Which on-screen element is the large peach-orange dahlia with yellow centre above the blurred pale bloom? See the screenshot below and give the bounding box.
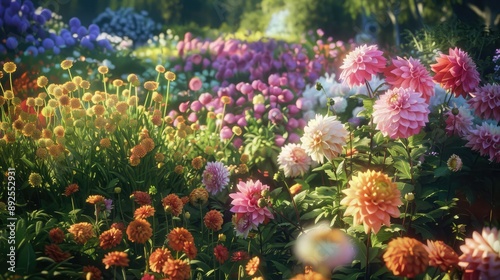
[340,170,403,234]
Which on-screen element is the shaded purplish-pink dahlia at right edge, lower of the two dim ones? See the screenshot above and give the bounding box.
[465,122,500,162]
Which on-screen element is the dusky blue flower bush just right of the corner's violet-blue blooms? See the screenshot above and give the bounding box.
[93,8,161,46]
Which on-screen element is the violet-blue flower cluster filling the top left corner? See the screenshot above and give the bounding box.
[0,0,113,56]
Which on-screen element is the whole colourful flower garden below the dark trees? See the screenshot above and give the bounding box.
[0,0,500,279]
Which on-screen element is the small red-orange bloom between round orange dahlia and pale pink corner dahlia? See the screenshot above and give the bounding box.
[426,240,458,272]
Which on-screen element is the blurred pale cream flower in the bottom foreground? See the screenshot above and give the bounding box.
[294,223,355,271]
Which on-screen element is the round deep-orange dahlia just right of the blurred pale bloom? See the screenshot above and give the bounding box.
[383,237,429,278]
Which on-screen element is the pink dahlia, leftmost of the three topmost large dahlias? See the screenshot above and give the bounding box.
[340,45,387,88]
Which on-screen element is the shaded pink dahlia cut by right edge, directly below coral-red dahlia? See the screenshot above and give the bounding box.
[467,84,500,122]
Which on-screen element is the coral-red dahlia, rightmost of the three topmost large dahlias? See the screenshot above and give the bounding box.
[431,48,480,97]
